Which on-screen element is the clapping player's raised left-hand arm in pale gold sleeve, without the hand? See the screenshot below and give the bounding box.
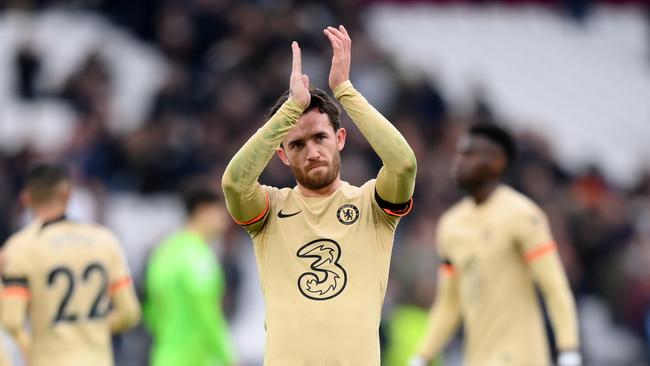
[221,100,302,222]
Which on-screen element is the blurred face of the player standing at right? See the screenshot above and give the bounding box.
[451,135,500,190]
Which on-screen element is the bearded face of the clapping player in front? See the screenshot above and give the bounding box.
[278,109,345,190]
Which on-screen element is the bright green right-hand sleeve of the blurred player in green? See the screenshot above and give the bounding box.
[183,254,234,365]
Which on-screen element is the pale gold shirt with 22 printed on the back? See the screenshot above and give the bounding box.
[3,220,130,366]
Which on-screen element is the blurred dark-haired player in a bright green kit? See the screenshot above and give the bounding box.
[144,183,234,366]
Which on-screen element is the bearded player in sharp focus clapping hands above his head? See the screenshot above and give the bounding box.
[222,26,416,366]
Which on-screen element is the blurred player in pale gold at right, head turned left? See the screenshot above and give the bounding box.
[411,124,581,366]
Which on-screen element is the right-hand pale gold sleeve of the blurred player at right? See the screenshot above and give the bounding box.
[515,206,579,351]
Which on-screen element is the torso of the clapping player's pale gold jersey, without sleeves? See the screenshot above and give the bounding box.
[244,180,399,366]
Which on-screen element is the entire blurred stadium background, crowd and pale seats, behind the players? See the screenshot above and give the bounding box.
[0,0,650,366]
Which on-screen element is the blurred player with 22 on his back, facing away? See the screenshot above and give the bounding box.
[1,163,140,366]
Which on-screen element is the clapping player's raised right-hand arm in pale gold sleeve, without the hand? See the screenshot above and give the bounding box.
[334,81,417,203]
